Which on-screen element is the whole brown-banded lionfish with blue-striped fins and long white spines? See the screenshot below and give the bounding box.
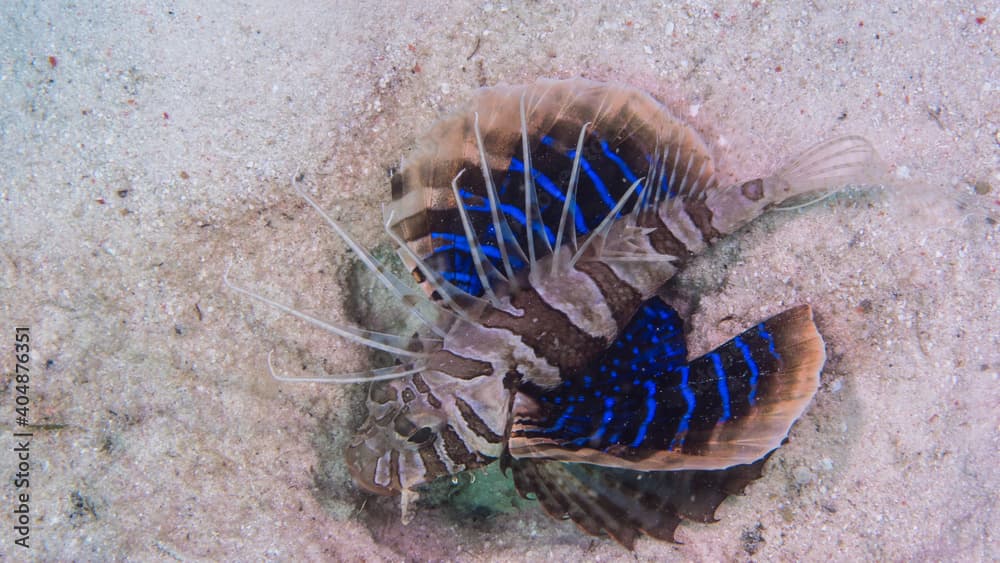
[227,79,877,549]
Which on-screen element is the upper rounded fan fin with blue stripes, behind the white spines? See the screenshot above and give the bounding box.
[387,80,716,302]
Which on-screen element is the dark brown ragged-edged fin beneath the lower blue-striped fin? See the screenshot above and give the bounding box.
[511,454,770,549]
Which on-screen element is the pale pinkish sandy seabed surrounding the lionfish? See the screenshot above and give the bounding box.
[0,1,1000,561]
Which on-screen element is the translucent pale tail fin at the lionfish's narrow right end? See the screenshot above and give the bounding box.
[705,135,884,234]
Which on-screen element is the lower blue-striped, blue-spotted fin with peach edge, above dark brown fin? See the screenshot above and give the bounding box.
[508,299,825,471]
